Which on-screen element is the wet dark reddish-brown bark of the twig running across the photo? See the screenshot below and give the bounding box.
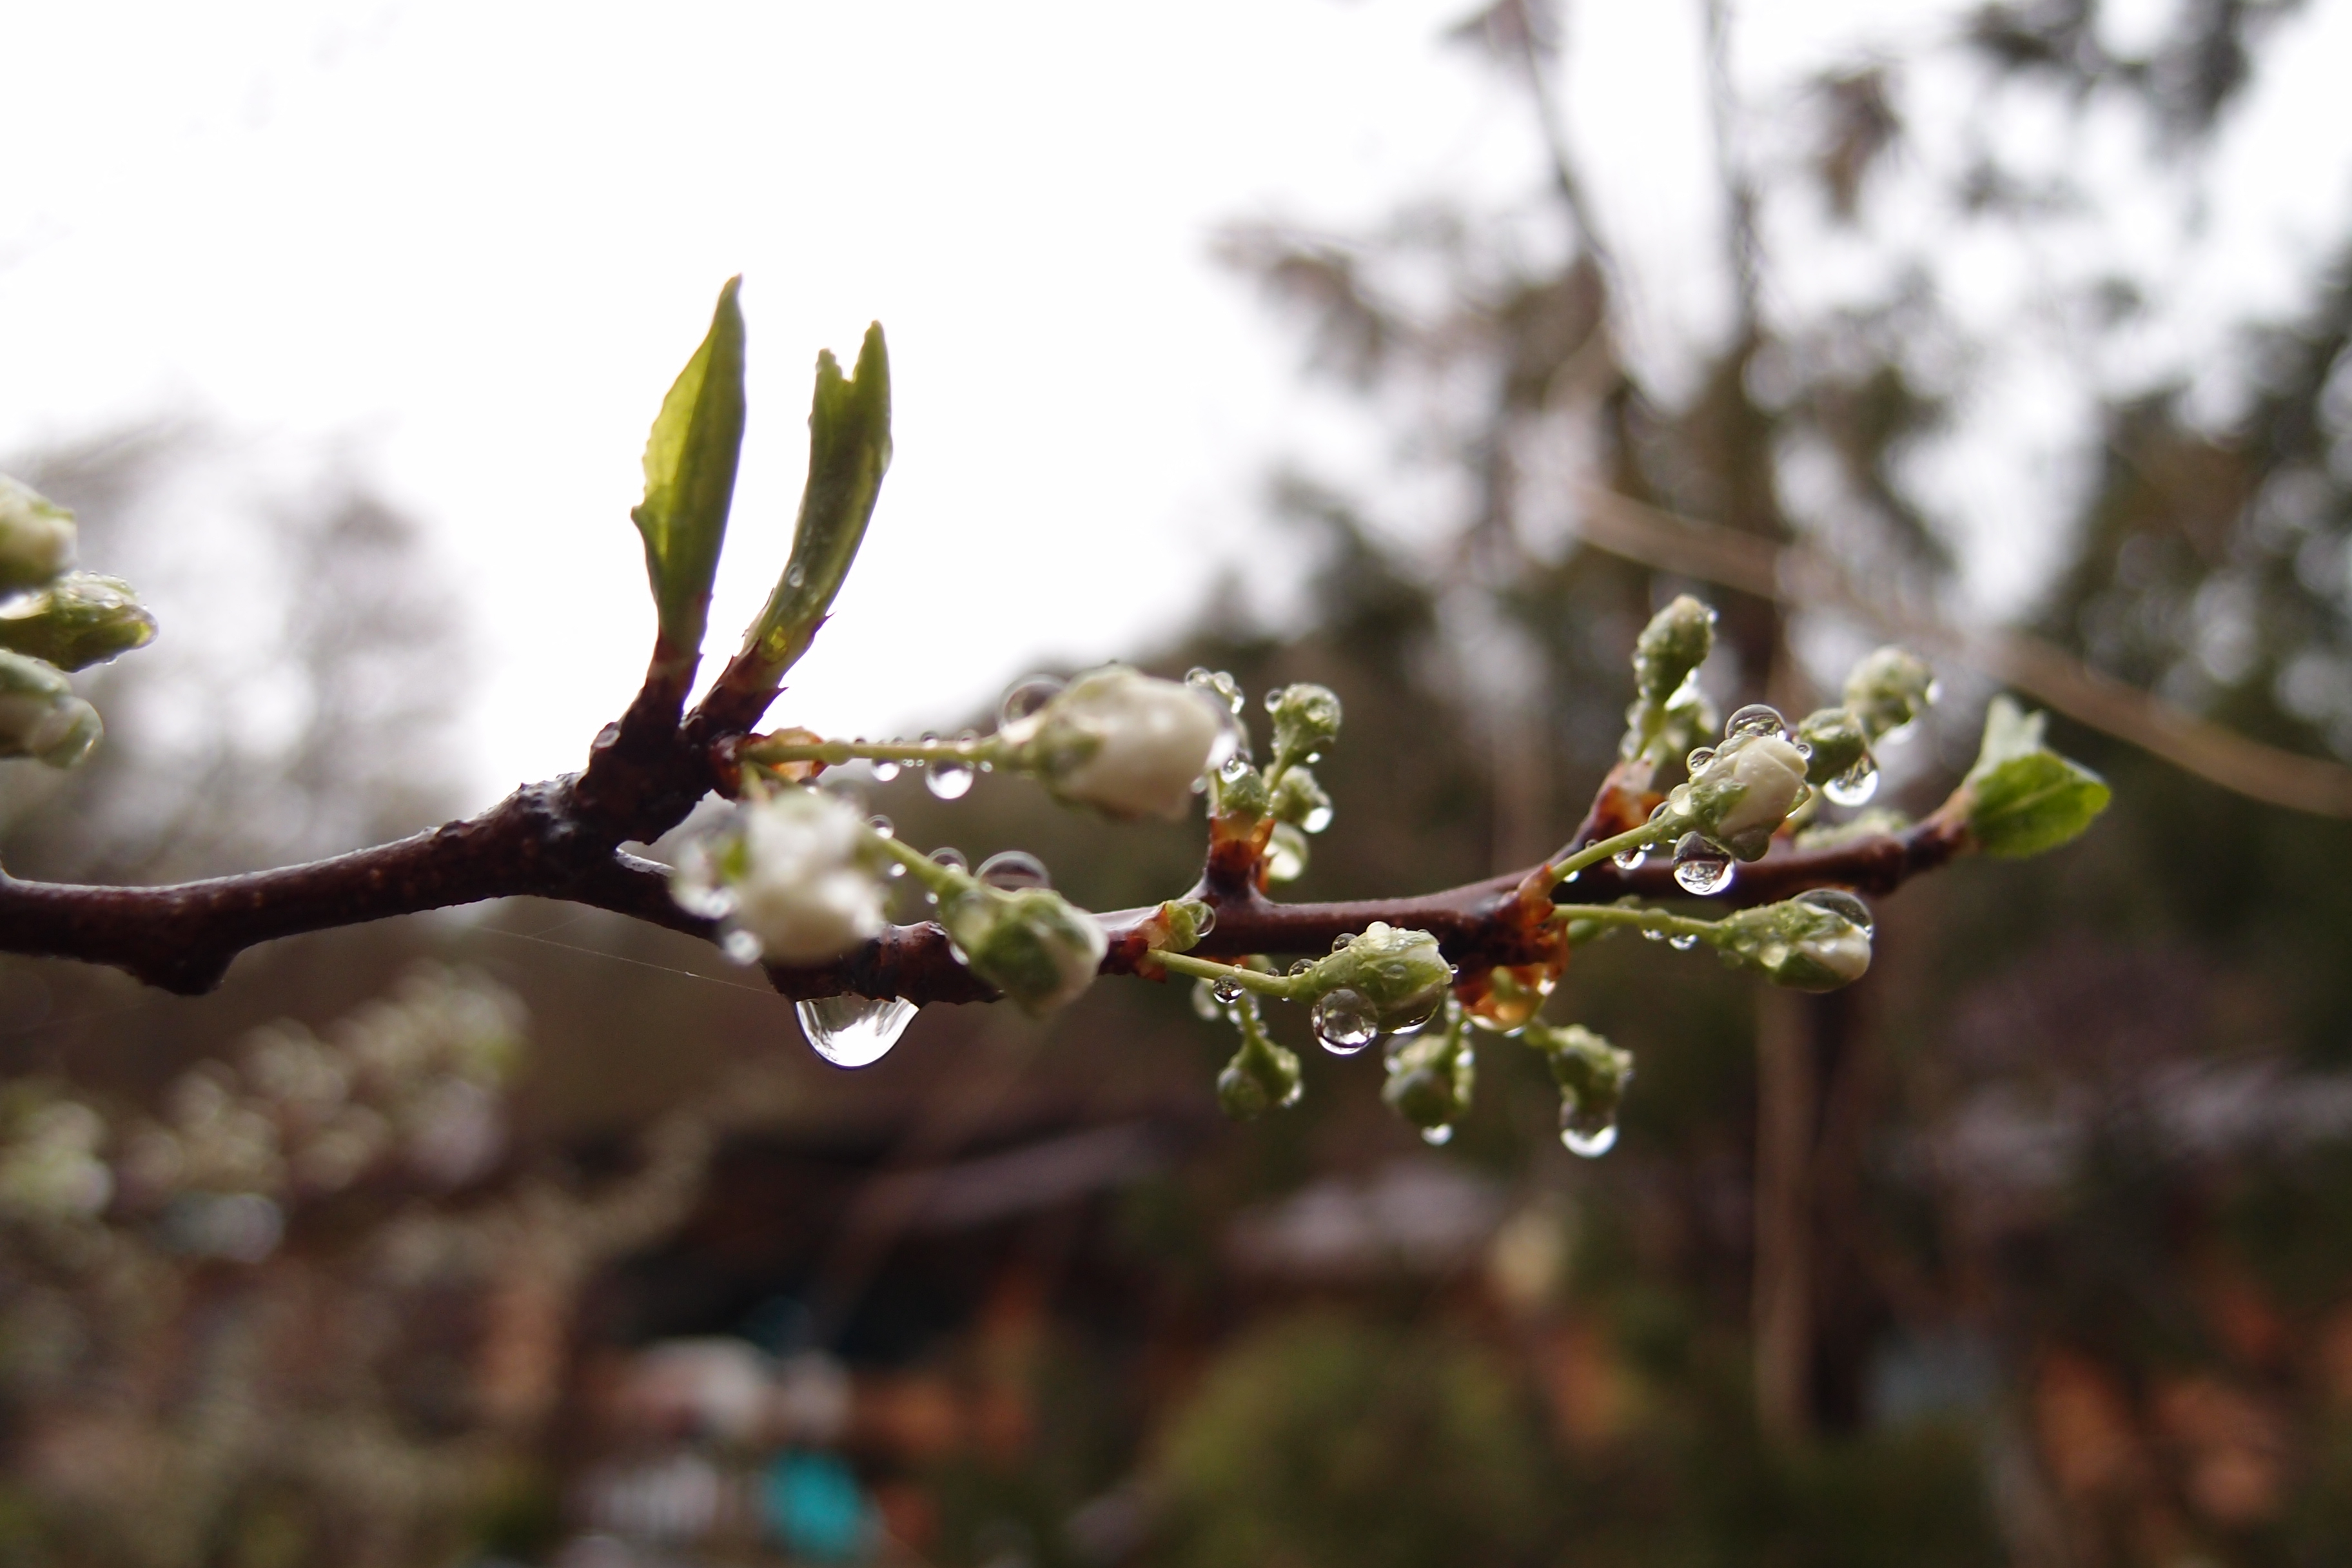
[0,625,1968,1004]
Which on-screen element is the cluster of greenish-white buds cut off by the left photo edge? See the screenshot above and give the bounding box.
[0,475,155,769]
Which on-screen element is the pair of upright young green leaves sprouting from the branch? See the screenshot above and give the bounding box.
[631,277,889,689]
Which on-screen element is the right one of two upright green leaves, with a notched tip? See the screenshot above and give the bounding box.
[743,322,889,684]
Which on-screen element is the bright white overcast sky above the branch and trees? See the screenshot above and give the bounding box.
[0,0,2345,792]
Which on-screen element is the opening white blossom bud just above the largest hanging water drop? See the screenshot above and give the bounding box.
[671,790,887,964]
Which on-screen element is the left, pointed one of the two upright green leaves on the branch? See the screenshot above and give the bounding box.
[631,277,743,663]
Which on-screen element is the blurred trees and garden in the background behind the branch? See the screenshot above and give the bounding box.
[0,0,2352,1568]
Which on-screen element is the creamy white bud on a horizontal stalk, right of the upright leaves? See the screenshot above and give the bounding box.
[1004,665,1233,821]
